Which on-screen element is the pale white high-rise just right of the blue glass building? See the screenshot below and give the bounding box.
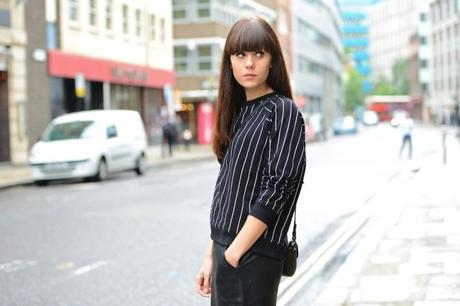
[369,0,431,119]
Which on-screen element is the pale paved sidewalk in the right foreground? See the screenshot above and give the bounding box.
[311,135,460,306]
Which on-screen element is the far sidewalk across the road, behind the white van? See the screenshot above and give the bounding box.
[0,145,215,189]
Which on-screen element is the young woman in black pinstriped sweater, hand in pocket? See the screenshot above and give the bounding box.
[196,17,306,306]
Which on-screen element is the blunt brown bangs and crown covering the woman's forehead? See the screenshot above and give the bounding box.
[225,18,275,56]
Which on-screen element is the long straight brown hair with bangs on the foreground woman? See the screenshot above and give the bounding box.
[212,17,292,160]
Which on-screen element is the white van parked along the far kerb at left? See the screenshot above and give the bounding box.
[29,110,147,185]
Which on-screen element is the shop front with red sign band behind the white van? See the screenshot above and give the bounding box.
[48,50,175,144]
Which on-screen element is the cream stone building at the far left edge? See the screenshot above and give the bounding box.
[0,0,30,164]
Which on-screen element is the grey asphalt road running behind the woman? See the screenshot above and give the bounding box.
[0,124,452,306]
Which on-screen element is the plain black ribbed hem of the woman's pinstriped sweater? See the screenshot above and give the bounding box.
[211,227,287,259]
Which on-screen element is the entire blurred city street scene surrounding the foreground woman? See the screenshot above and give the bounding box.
[0,0,460,306]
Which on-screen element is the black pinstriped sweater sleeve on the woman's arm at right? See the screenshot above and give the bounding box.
[249,99,306,225]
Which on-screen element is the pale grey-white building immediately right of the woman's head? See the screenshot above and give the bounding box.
[291,0,344,128]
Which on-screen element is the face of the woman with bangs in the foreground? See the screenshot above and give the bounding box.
[230,50,272,92]
